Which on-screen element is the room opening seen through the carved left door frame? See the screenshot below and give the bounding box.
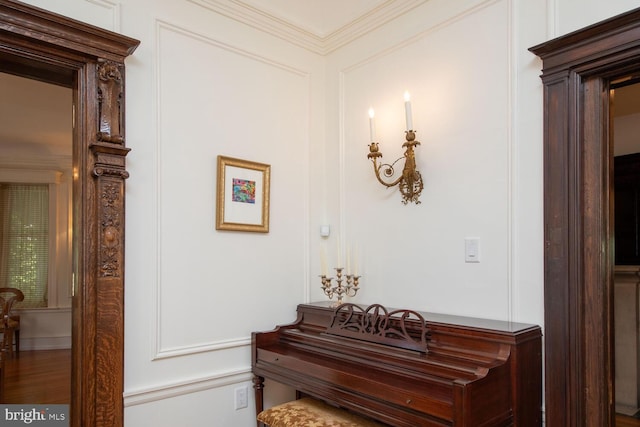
[0,73,73,404]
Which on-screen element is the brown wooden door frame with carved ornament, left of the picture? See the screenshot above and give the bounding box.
[0,0,139,427]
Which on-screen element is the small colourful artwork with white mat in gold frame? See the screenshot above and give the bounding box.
[216,156,271,233]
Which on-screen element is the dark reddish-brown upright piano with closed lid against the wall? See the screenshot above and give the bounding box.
[252,301,542,427]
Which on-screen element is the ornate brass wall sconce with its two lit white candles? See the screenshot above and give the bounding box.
[367,92,424,205]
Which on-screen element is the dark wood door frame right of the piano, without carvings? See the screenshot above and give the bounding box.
[530,9,640,427]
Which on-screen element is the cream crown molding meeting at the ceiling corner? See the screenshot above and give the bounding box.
[189,0,428,55]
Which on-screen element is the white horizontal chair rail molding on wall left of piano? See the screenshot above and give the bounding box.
[124,369,253,407]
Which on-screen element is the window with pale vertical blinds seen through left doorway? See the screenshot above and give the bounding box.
[0,183,49,308]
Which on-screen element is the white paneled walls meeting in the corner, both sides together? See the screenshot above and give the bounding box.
[17,0,636,427]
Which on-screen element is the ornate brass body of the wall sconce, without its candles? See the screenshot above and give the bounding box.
[367,130,424,205]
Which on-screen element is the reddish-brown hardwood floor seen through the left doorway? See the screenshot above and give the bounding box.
[2,349,71,404]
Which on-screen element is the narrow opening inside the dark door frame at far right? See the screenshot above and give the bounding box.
[609,80,640,427]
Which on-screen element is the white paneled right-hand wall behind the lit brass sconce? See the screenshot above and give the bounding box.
[328,0,545,323]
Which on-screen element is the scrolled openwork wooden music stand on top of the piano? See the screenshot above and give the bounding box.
[327,303,430,353]
